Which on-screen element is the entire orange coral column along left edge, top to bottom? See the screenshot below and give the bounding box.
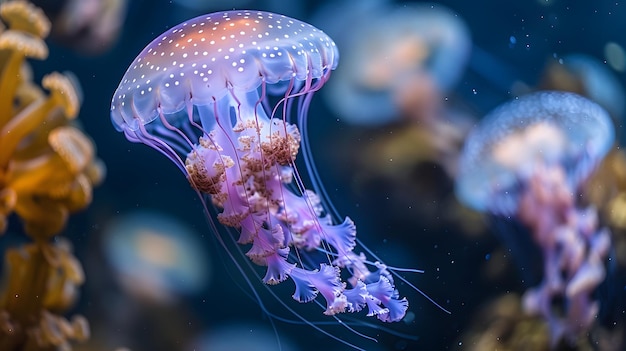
[0,0,105,351]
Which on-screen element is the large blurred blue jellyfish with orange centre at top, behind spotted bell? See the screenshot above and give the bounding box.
[319,1,471,126]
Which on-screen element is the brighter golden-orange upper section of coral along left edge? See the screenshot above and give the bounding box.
[0,1,103,238]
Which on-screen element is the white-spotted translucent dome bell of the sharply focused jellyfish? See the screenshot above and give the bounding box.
[111,10,339,131]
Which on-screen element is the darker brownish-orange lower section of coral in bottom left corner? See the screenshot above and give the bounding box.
[0,241,89,351]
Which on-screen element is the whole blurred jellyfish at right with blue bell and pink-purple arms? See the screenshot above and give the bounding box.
[456,91,615,346]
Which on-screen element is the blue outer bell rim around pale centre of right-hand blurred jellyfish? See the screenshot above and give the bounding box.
[455,91,615,215]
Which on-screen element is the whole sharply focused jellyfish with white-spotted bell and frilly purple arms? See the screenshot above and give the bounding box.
[111,11,428,346]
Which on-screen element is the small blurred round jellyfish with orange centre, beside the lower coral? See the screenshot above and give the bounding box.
[103,211,211,304]
